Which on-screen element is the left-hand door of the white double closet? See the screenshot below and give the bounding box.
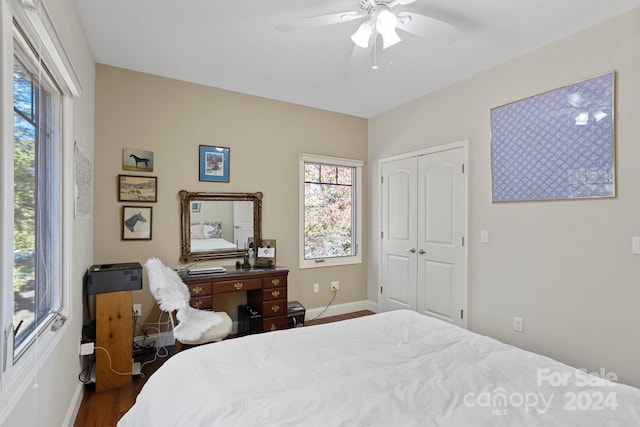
[379,157,418,311]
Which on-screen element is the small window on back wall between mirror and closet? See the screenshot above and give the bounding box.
[300,154,362,268]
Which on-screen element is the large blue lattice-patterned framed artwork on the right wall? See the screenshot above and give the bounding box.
[491,72,615,202]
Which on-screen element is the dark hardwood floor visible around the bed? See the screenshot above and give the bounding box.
[74,310,374,427]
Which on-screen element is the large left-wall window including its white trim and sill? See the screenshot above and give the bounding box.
[0,0,82,402]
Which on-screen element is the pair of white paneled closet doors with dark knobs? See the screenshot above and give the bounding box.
[378,147,467,327]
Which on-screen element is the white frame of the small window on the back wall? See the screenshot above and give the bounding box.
[298,153,364,269]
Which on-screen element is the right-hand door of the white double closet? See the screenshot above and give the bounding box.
[417,148,466,326]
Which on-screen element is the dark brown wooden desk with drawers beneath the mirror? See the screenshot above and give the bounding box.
[180,267,289,331]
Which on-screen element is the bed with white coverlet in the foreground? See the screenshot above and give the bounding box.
[118,310,640,427]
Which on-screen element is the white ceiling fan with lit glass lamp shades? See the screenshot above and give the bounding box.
[276,0,459,49]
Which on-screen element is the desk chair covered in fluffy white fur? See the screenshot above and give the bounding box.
[144,258,232,353]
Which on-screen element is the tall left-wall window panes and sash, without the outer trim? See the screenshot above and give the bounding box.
[13,31,62,354]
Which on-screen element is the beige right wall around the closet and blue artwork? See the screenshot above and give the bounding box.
[368,9,640,386]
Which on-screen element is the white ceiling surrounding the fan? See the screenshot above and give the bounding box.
[76,0,640,118]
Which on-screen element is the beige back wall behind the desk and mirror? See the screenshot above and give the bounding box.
[94,65,367,321]
